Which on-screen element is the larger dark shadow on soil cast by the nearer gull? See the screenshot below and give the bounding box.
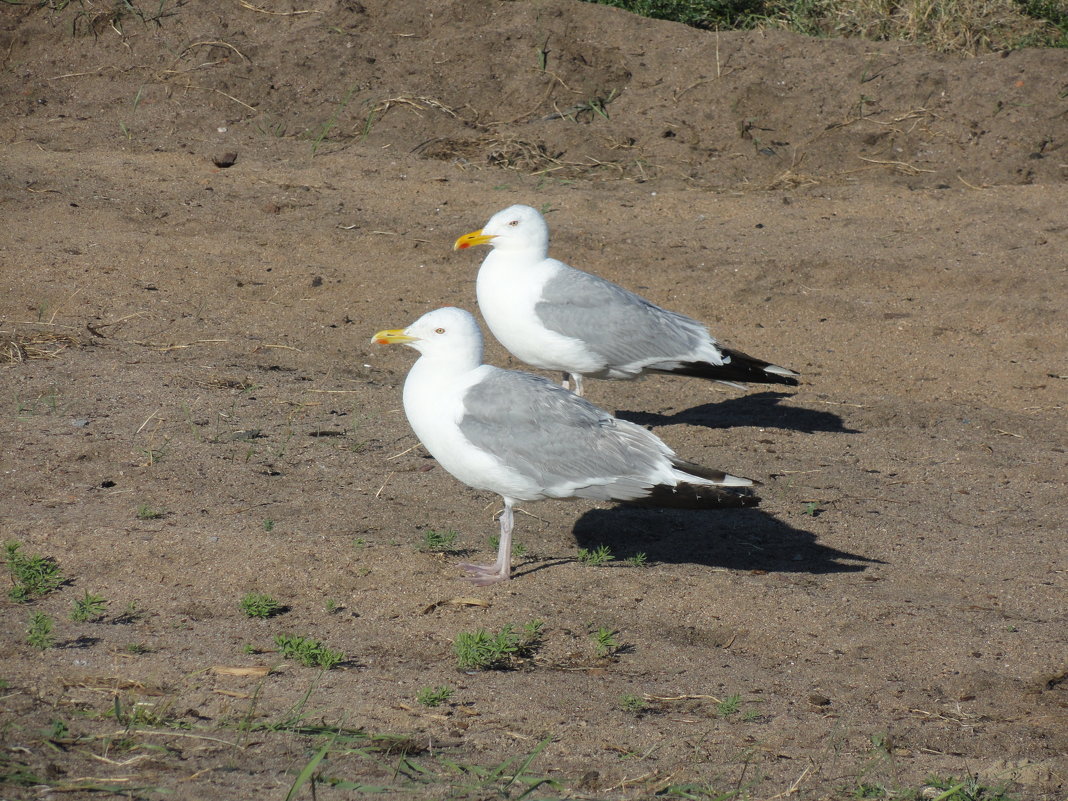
[574,506,885,574]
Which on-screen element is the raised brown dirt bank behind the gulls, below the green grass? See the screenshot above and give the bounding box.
[8,0,1068,189]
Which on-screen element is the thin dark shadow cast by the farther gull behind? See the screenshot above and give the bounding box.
[616,392,860,434]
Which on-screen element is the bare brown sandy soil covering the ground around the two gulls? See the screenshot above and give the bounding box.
[0,0,1068,801]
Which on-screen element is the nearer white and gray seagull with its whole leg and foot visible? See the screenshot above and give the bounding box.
[371,308,759,584]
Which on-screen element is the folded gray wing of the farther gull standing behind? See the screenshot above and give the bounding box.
[534,267,714,366]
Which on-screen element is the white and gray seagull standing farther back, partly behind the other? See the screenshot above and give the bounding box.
[453,205,799,395]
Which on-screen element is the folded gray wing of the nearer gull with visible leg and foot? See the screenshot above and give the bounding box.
[459,370,671,500]
